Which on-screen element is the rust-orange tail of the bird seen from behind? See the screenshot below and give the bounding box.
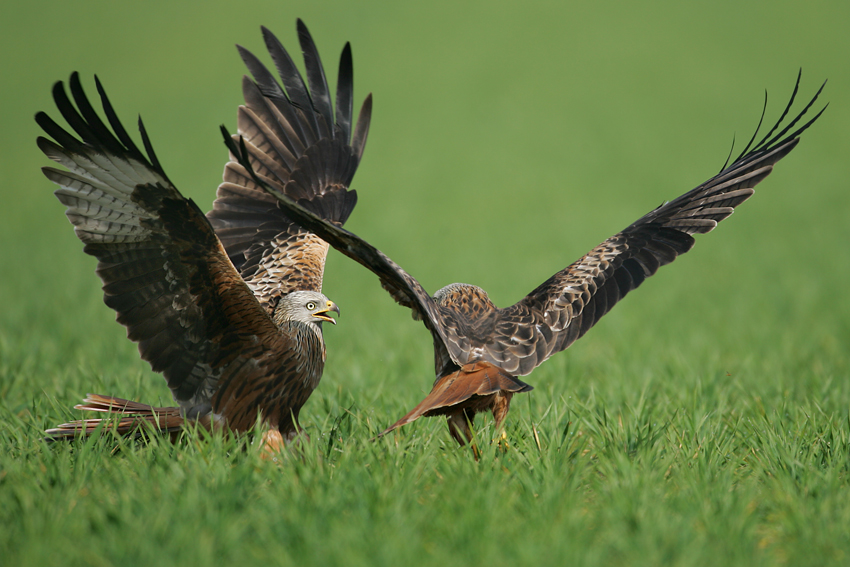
[379,361,532,437]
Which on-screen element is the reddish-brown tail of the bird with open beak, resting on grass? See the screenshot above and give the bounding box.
[45,394,183,440]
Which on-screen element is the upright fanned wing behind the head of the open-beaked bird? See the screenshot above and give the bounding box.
[207,19,372,310]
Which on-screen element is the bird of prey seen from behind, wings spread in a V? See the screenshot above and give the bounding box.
[224,75,823,448]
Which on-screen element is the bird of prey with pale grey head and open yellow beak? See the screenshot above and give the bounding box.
[36,20,372,449]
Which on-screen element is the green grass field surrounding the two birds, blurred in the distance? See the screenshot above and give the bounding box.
[0,0,850,566]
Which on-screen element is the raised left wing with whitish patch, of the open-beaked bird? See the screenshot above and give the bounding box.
[36,73,318,428]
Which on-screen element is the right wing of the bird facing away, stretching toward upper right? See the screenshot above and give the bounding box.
[482,75,825,375]
